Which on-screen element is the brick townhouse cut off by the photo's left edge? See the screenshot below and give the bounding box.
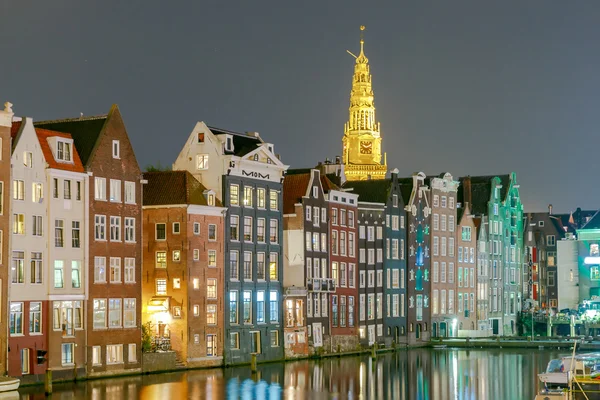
[0,102,14,375]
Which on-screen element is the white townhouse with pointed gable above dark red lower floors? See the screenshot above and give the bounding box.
[7,118,48,382]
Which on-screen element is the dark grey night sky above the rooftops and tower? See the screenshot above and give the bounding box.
[0,0,600,212]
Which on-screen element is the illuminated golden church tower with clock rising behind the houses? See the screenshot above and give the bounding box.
[342,26,387,181]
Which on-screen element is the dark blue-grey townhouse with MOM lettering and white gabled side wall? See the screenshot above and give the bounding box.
[173,122,288,365]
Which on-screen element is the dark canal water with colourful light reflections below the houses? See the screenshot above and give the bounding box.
[17,349,568,400]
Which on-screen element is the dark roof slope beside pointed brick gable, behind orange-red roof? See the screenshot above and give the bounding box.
[34,115,107,165]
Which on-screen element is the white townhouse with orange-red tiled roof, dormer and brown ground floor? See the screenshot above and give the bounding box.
[38,128,88,379]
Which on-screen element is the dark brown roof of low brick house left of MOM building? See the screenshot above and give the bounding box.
[143,171,221,207]
